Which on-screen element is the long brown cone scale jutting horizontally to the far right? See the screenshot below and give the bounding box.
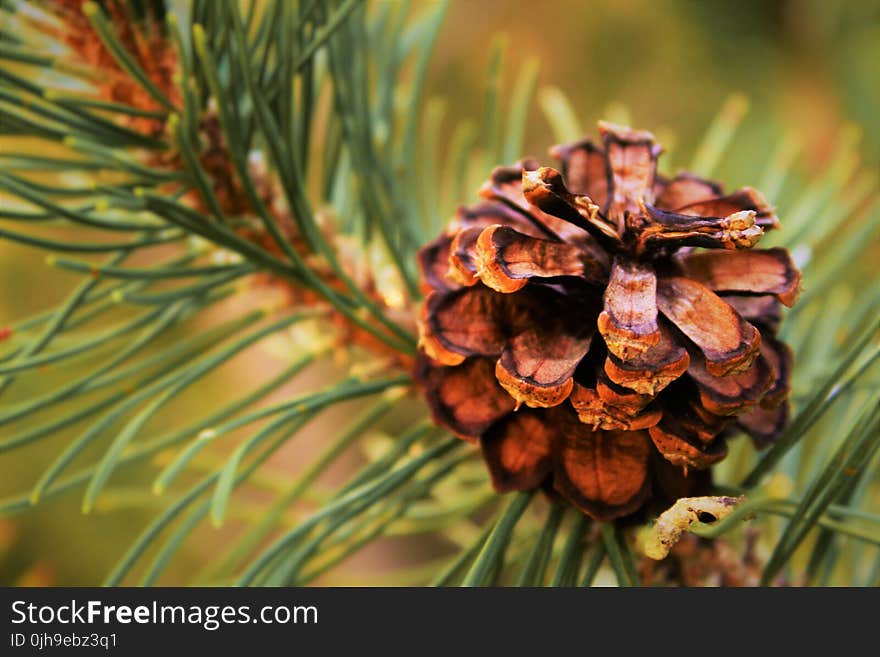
[679,248,801,306]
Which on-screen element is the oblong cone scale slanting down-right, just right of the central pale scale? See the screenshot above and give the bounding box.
[657,276,761,376]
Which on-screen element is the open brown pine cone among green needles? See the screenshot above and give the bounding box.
[416,123,800,520]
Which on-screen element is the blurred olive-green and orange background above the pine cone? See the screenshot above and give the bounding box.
[440,0,880,167]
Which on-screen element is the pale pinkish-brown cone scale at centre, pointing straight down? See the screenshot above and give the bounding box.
[598,257,660,362]
